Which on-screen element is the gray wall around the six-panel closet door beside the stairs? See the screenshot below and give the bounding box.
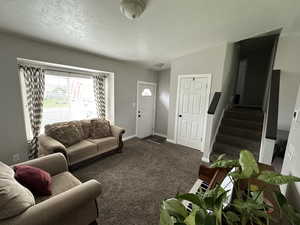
[168,44,227,140]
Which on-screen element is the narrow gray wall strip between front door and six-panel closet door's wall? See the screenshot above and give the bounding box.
[155,69,171,136]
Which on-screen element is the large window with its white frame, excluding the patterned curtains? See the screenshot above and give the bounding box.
[17,58,115,140]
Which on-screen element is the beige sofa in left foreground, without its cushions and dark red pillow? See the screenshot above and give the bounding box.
[0,153,101,225]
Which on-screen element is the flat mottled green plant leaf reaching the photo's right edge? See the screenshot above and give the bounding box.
[257,170,300,185]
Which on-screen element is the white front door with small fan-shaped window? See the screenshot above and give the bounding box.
[137,82,156,138]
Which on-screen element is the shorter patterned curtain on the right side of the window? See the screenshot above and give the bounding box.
[93,74,106,119]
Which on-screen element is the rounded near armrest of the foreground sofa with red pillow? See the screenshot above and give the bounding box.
[5,180,101,225]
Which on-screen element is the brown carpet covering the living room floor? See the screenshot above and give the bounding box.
[73,138,202,225]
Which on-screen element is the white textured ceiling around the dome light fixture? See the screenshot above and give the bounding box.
[0,0,300,68]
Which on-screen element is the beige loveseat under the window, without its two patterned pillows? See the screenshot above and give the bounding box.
[39,120,125,168]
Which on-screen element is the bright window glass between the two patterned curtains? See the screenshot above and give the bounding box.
[41,75,97,128]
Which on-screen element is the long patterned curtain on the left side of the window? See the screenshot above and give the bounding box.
[19,65,45,159]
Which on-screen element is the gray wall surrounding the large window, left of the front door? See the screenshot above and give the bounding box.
[0,34,157,163]
